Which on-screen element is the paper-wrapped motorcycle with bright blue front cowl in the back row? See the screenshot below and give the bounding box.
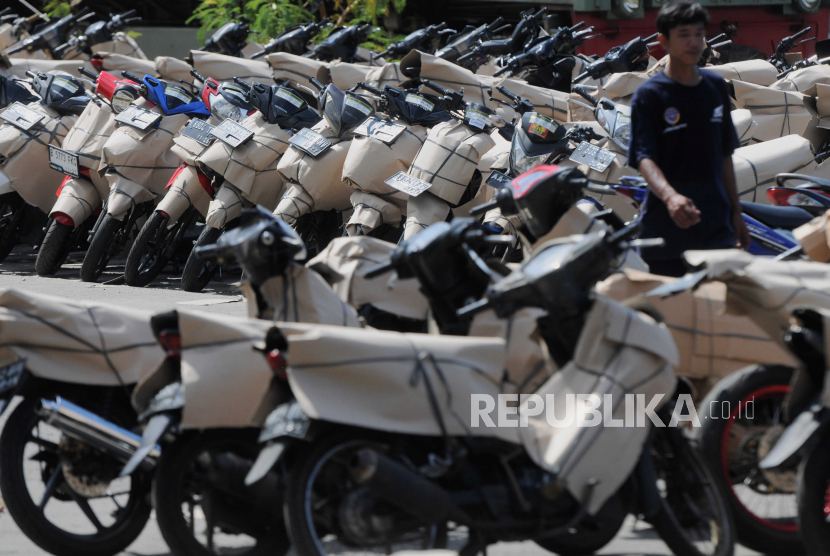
[81,72,210,282]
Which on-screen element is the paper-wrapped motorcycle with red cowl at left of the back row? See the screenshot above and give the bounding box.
[35,68,138,276]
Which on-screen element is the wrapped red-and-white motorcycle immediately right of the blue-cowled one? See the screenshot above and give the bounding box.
[124,69,256,287]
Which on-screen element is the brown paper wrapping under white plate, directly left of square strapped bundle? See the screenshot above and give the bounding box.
[341,120,428,207]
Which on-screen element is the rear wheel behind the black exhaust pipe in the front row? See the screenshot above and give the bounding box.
[284,435,456,556]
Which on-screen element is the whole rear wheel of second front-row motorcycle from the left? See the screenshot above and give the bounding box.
[153,430,290,556]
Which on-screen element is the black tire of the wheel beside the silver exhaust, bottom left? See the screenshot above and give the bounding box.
[0,399,152,556]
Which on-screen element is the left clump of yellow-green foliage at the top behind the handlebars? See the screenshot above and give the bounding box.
[186,0,314,44]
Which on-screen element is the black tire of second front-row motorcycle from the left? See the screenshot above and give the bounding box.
[153,430,290,556]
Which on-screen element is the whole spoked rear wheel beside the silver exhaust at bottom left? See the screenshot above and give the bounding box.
[0,399,151,556]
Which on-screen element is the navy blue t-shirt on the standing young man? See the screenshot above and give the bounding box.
[628,69,738,260]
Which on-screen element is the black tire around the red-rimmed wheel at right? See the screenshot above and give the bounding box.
[697,365,804,556]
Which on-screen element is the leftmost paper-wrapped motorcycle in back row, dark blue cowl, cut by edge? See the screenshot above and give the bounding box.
[0,72,90,261]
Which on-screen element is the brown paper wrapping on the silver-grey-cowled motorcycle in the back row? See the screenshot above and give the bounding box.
[275,120,353,217]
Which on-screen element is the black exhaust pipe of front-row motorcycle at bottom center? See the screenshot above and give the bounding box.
[350,448,473,525]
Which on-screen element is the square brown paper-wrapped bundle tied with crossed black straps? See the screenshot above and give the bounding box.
[409,120,495,205]
